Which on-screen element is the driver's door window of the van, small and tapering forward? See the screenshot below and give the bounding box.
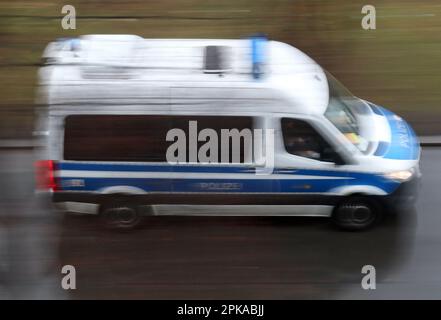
[282,118,341,162]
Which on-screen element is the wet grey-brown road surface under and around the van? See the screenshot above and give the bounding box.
[0,148,441,299]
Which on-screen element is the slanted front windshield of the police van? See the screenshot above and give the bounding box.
[325,72,367,152]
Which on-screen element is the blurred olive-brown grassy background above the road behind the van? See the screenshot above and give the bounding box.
[0,0,441,139]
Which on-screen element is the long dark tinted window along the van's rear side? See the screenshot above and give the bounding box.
[64,115,253,163]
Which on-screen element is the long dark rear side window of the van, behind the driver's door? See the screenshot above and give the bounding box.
[64,115,253,162]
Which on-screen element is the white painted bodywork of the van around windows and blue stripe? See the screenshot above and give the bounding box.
[39,35,419,216]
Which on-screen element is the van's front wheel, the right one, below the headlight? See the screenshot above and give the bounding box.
[332,196,383,231]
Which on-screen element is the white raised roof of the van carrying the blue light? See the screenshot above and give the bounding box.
[40,35,328,114]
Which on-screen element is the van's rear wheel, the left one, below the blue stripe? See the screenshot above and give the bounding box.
[100,201,142,231]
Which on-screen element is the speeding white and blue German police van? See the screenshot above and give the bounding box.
[36,35,420,230]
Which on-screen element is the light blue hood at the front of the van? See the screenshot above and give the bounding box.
[369,103,421,160]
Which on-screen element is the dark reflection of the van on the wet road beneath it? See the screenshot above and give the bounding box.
[59,205,416,299]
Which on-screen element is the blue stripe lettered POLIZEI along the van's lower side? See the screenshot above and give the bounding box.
[57,162,399,193]
